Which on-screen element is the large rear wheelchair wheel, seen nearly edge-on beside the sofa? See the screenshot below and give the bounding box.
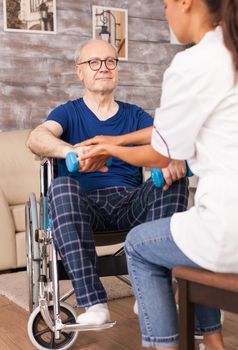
[25,193,40,312]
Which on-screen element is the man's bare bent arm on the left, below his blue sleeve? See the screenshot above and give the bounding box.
[26,120,73,158]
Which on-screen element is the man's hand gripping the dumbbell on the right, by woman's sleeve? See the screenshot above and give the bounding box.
[161,160,187,191]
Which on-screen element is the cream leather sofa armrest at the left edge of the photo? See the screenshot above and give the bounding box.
[0,188,17,270]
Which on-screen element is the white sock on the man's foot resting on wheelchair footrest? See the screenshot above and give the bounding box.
[76,303,111,326]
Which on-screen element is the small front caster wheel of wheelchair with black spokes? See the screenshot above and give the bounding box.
[27,303,78,350]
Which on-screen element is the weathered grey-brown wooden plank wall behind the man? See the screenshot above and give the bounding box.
[0,0,184,130]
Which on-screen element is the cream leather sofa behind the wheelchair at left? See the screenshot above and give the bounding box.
[0,130,40,271]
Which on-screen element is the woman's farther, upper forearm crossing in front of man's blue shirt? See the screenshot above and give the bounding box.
[120,126,152,146]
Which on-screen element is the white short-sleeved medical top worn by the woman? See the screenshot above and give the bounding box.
[152,27,238,272]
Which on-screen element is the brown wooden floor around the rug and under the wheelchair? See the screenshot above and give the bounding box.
[0,296,238,350]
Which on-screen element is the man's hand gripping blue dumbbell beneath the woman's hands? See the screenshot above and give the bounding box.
[74,145,108,173]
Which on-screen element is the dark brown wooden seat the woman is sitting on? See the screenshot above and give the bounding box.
[173,266,238,350]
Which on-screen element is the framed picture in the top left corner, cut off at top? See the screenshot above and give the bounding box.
[3,0,56,34]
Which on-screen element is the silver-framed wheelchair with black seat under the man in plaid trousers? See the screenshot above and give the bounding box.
[25,158,130,350]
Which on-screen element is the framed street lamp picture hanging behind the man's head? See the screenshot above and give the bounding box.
[92,6,128,60]
